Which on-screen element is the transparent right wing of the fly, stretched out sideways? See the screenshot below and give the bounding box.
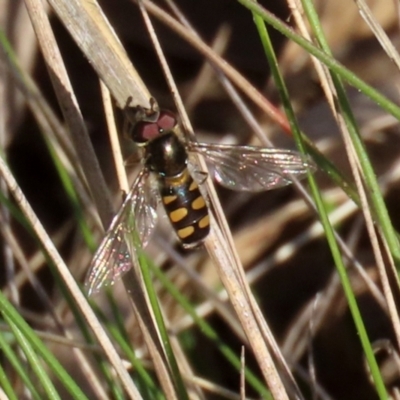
[188,142,315,192]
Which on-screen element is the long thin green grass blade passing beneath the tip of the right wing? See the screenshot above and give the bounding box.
[253,13,387,399]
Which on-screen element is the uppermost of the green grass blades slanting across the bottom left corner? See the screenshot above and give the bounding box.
[0,292,87,399]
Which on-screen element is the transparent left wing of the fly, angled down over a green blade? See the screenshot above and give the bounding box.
[85,170,159,296]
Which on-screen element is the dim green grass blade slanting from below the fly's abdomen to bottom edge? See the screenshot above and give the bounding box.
[149,261,272,400]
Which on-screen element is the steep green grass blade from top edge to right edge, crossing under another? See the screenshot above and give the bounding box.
[303,0,400,271]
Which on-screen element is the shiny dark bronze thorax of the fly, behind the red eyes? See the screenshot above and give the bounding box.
[145,132,188,177]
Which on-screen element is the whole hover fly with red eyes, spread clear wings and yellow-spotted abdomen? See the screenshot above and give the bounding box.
[85,105,314,295]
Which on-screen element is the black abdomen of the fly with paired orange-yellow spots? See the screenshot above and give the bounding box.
[160,171,210,247]
